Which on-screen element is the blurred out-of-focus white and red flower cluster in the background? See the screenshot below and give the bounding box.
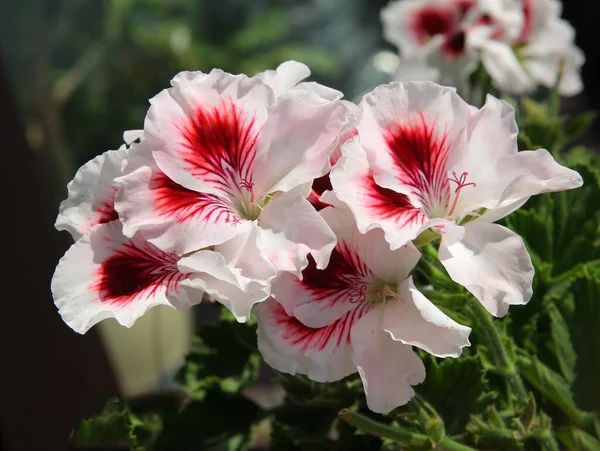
[381,0,585,96]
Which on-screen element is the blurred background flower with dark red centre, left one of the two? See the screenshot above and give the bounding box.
[381,0,477,90]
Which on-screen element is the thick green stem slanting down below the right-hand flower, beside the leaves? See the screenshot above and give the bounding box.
[471,299,528,402]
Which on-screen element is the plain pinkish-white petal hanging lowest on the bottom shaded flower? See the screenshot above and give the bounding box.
[351,308,425,413]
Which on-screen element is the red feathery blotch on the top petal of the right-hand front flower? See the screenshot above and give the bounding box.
[385,114,450,216]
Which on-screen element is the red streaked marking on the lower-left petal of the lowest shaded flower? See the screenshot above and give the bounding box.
[272,303,373,352]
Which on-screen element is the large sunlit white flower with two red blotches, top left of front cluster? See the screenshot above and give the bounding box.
[116,61,346,282]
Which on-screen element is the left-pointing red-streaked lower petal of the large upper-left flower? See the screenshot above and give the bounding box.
[115,165,252,255]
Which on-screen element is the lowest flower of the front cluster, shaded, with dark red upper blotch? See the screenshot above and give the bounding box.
[255,207,470,413]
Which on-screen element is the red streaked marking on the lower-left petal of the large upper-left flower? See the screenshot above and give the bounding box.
[151,171,240,223]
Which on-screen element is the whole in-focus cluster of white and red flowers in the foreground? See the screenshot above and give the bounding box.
[52,61,582,412]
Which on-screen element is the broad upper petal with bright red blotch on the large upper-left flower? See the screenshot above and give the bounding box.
[144,70,273,197]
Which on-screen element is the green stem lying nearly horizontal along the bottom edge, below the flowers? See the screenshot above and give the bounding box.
[338,409,476,451]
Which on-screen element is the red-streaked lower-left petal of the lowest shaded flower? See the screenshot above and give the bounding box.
[255,298,368,382]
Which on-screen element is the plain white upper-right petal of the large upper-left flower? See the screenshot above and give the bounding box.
[253,90,346,194]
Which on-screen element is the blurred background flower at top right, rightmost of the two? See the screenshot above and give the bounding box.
[470,0,585,96]
